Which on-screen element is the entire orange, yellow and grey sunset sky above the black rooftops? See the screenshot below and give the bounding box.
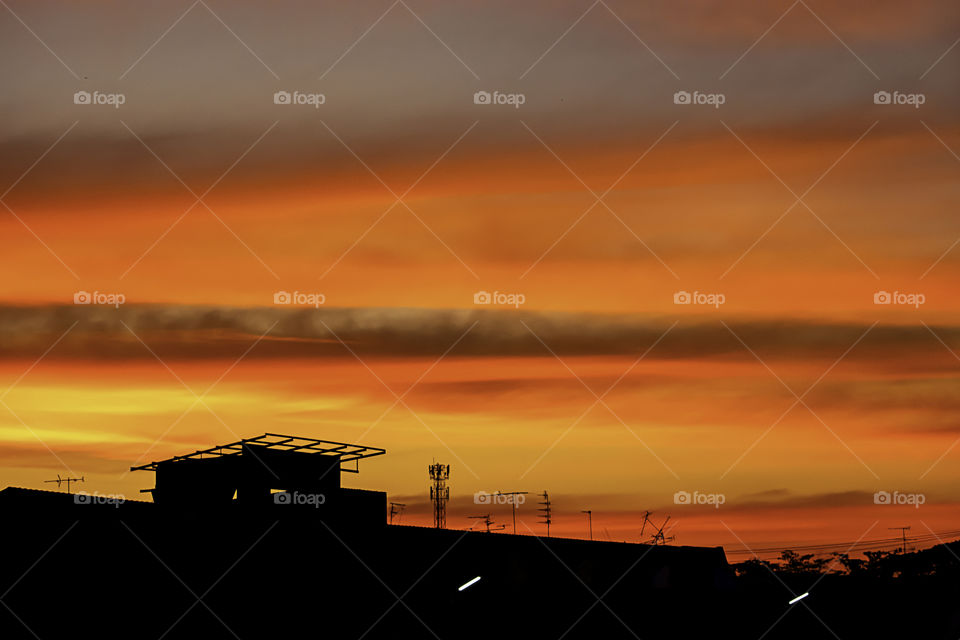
[0,0,960,552]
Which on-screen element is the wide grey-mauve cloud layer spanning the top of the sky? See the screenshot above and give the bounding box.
[0,0,960,208]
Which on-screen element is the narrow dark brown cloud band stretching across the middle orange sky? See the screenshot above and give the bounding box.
[0,305,960,360]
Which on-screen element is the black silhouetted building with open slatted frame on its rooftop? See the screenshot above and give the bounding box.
[0,433,764,640]
